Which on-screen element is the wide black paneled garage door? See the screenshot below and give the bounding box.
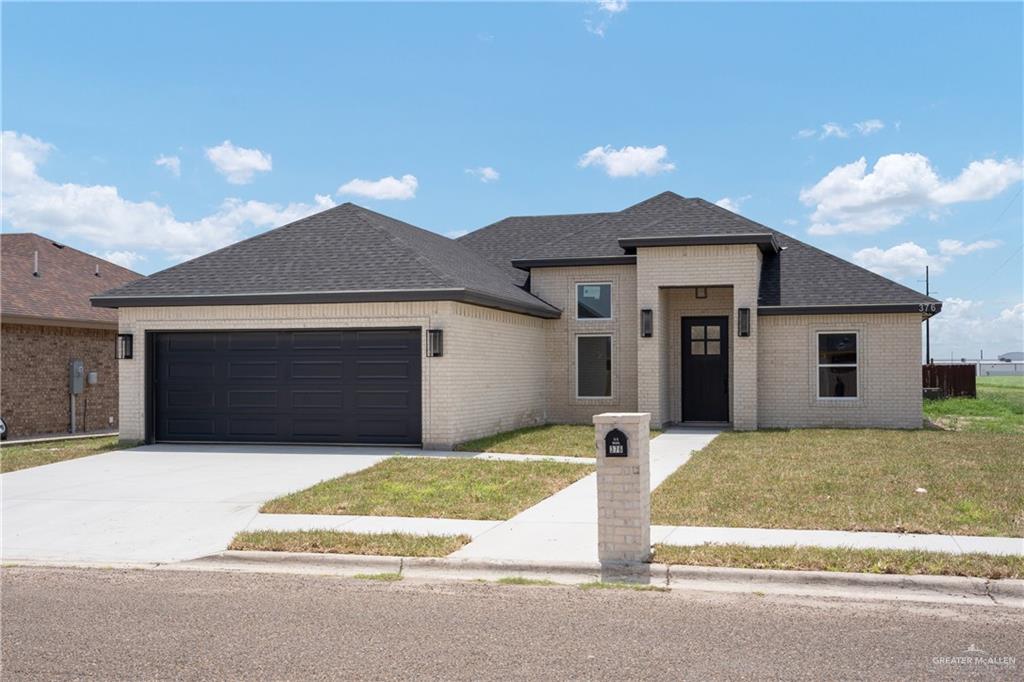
[152,330,422,444]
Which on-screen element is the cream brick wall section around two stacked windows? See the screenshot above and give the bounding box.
[530,265,640,424]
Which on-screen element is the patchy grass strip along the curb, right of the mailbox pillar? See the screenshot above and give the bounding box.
[654,545,1024,579]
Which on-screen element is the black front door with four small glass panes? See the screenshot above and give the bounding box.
[682,317,729,422]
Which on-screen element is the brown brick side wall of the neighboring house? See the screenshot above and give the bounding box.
[0,324,118,438]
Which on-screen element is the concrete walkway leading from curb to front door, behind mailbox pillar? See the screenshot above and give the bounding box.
[452,428,720,562]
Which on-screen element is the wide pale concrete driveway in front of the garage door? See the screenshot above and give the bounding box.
[0,445,428,563]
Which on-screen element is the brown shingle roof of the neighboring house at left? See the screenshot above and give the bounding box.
[0,233,142,328]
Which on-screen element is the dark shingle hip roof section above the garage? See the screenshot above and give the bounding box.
[93,204,560,317]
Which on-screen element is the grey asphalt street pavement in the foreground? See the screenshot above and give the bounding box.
[0,567,1024,681]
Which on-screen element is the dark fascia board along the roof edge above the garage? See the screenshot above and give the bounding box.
[90,289,561,319]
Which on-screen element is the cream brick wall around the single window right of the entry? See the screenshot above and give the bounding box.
[758,313,922,428]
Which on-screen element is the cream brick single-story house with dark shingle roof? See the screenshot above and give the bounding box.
[93,193,940,447]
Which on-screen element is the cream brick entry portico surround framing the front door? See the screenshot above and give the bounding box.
[637,245,761,430]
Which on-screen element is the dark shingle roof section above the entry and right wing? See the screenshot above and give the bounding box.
[460,191,941,313]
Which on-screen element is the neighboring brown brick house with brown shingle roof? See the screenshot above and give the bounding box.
[0,233,142,438]
